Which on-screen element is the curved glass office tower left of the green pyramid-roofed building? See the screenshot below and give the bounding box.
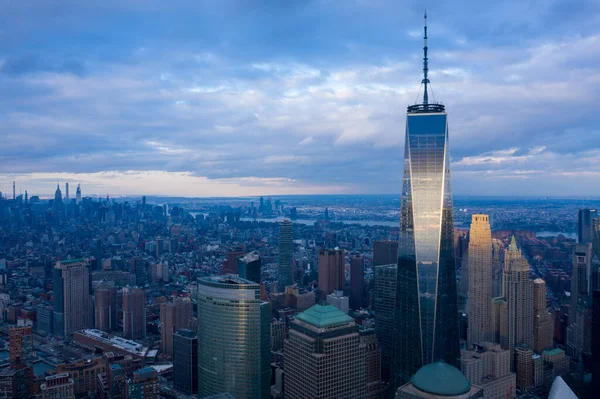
[197,275,271,399]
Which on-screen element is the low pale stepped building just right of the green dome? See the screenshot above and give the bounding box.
[460,342,516,399]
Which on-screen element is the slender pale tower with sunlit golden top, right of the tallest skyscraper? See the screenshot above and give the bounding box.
[467,214,493,346]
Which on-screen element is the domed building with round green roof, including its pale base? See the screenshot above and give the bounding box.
[396,362,483,399]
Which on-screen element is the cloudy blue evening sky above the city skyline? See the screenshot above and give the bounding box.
[0,0,600,197]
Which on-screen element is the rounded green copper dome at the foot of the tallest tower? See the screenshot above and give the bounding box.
[411,362,471,396]
